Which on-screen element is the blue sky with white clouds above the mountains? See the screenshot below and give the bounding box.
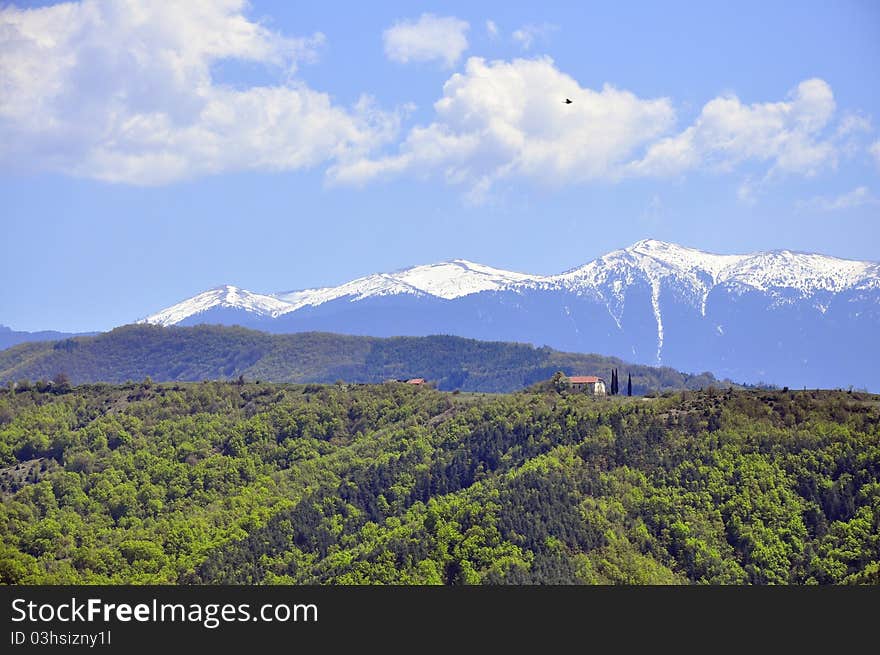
[0,0,880,331]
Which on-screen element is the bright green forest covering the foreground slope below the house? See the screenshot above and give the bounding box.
[0,380,880,585]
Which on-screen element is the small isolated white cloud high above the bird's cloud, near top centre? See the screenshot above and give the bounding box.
[382,14,470,68]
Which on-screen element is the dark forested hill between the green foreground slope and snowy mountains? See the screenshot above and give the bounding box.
[0,325,718,393]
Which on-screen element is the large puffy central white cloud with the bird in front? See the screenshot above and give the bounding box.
[330,57,675,192]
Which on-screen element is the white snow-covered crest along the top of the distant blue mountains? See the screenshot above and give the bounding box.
[137,239,880,327]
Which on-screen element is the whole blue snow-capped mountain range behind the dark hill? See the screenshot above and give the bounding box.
[136,240,880,388]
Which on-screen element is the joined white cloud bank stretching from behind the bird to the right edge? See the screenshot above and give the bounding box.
[328,57,860,197]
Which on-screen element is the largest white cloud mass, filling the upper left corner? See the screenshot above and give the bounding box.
[0,0,397,184]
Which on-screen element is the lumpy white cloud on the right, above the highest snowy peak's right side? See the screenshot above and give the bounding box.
[630,79,838,176]
